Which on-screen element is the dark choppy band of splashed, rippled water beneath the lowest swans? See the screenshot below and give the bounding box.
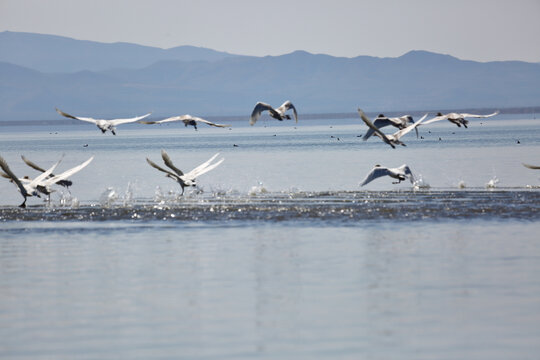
[0,189,540,223]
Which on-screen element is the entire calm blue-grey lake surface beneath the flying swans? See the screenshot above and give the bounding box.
[0,115,540,359]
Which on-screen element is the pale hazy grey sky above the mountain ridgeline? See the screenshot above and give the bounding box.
[0,0,540,62]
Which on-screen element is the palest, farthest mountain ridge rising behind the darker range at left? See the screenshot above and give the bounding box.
[0,31,235,73]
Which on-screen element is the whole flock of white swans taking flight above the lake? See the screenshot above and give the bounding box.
[0,100,540,208]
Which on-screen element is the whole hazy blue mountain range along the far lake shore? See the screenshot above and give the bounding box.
[0,32,540,120]
